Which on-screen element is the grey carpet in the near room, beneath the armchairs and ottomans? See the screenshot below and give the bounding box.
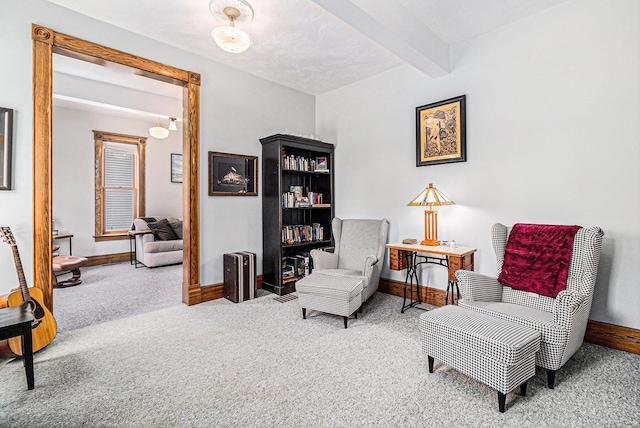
[0,293,640,428]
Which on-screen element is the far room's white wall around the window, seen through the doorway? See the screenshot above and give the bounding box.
[53,106,182,257]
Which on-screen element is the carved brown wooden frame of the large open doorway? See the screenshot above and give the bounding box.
[31,24,201,311]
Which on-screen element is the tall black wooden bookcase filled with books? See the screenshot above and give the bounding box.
[260,134,335,295]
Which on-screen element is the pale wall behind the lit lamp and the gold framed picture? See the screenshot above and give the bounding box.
[316,0,640,328]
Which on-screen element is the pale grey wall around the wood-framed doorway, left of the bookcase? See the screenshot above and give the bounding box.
[0,0,315,294]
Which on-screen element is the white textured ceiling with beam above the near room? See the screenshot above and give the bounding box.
[49,0,567,95]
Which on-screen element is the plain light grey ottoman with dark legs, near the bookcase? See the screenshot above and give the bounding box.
[296,273,363,328]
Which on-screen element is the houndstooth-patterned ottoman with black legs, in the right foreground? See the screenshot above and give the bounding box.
[420,305,540,412]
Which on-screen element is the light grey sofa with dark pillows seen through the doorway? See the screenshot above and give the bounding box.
[133,216,182,267]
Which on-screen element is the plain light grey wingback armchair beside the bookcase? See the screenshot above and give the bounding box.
[311,217,389,303]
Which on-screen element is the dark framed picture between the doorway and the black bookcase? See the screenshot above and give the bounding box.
[209,152,258,196]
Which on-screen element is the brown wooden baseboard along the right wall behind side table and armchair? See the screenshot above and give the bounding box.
[378,278,640,354]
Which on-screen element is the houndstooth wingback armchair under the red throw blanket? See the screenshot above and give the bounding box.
[456,223,604,388]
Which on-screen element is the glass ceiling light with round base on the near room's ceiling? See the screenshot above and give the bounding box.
[209,0,253,53]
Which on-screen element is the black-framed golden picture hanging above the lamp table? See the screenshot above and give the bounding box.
[416,95,467,166]
